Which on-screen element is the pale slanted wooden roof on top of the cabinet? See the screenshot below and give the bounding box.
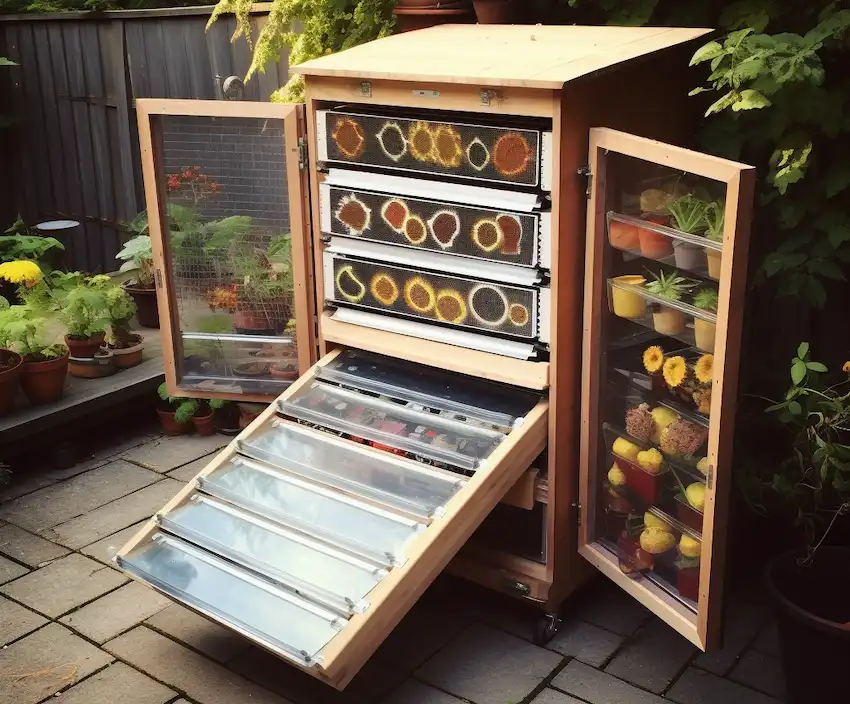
[291,24,711,89]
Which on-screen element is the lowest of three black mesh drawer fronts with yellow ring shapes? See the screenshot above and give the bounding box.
[326,257,537,338]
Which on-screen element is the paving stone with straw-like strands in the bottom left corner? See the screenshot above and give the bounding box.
[0,623,114,704]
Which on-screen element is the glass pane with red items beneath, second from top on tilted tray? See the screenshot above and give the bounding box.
[278,381,505,472]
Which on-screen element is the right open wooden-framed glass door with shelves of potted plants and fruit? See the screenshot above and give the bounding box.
[579,129,755,650]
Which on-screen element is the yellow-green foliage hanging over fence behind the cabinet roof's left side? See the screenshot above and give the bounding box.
[212,0,395,103]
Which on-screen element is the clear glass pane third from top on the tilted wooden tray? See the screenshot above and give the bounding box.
[239,419,466,519]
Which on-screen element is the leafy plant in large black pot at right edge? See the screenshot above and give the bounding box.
[747,342,850,704]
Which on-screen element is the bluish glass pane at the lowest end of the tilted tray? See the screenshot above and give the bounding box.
[119,533,346,665]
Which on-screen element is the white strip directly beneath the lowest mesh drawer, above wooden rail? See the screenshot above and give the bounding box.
[333,308,535,359]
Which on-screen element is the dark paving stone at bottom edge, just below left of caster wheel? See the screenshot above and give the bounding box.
[416,623,562,704]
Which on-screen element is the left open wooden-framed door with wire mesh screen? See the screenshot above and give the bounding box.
[137,100,315,401]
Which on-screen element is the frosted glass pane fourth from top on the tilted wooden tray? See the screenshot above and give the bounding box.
[200,458,425,567]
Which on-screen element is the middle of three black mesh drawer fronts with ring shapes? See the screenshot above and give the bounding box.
[325,186,540,266]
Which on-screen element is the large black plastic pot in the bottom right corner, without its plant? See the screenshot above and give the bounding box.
[766,547,850,704]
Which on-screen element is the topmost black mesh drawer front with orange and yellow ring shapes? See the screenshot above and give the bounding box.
[318,110,542,186]
